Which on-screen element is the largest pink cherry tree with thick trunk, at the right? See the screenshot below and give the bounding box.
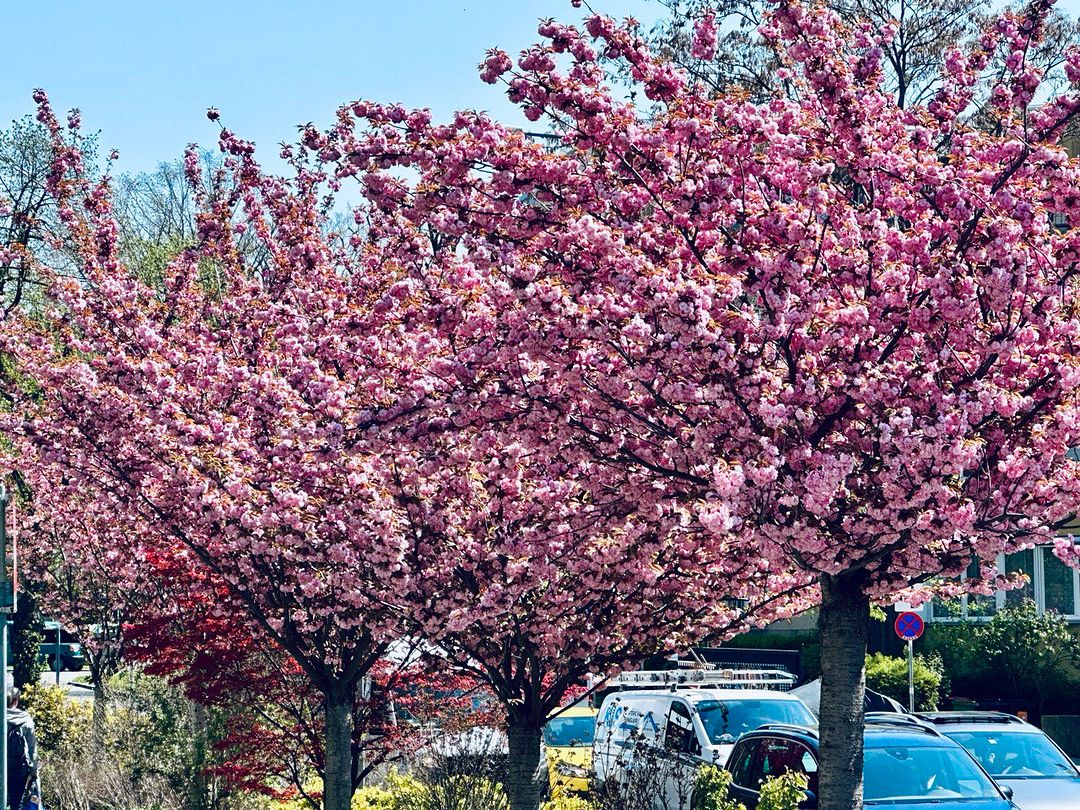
[282,2,1080,809]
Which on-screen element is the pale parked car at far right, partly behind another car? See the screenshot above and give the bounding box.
[919,712,1080,810]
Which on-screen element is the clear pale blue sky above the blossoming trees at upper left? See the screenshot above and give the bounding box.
[8,0,1080,177]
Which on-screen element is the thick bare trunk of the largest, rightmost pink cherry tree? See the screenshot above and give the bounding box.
[818,576,869,810]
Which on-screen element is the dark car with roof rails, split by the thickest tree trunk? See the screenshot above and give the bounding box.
[728,714,1016,810]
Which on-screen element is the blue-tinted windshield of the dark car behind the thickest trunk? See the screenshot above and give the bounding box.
[863,745,1001,805]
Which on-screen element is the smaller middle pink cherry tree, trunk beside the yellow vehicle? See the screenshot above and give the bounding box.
[395,419,809,810]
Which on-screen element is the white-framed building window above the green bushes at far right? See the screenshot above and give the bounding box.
[930,545,1080,622]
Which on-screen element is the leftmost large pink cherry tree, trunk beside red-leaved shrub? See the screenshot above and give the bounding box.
[3,94,460,810]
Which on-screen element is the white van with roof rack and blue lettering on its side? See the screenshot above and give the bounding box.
[593,686,818,810]
